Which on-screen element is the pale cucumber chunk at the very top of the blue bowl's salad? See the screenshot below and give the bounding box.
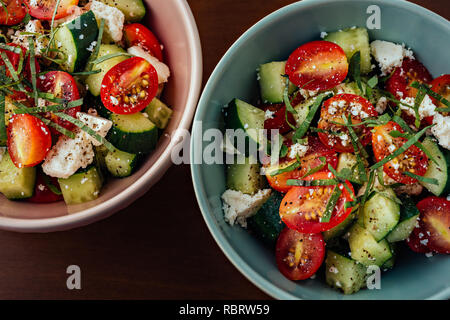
[324,28,372,74]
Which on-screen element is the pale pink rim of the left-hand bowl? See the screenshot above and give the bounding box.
[0,0,203,232]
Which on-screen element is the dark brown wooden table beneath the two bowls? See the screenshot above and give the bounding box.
[0,0,450,299]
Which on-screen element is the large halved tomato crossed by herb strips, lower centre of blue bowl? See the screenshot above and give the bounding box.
[280,172,354,233]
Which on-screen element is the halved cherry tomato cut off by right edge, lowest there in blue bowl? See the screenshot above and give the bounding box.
[417,197,450,254]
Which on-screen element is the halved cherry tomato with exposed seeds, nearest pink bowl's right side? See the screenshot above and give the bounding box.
[100,57,158,114]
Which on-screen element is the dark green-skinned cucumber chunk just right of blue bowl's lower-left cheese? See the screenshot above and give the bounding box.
[247,191,285,244]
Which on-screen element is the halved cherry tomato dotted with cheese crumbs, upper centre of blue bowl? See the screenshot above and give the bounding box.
[317,93,378,152]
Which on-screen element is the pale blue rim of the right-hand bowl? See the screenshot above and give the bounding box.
[190,0,450,300]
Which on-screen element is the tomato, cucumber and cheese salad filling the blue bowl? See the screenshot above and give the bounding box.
[222,27,450,294]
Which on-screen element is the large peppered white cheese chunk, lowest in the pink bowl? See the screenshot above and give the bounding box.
[42,129,94,178]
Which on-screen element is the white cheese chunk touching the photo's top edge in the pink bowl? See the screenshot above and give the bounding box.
[90,0,125,42]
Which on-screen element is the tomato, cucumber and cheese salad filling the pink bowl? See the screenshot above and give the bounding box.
[0,0,173,205]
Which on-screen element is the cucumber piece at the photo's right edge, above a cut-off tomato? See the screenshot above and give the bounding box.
[419,137,450,196]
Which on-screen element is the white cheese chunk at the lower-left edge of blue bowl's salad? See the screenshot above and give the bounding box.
[222,189,272,228]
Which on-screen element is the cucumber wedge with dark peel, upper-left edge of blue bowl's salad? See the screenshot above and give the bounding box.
[224,99,265,155]
